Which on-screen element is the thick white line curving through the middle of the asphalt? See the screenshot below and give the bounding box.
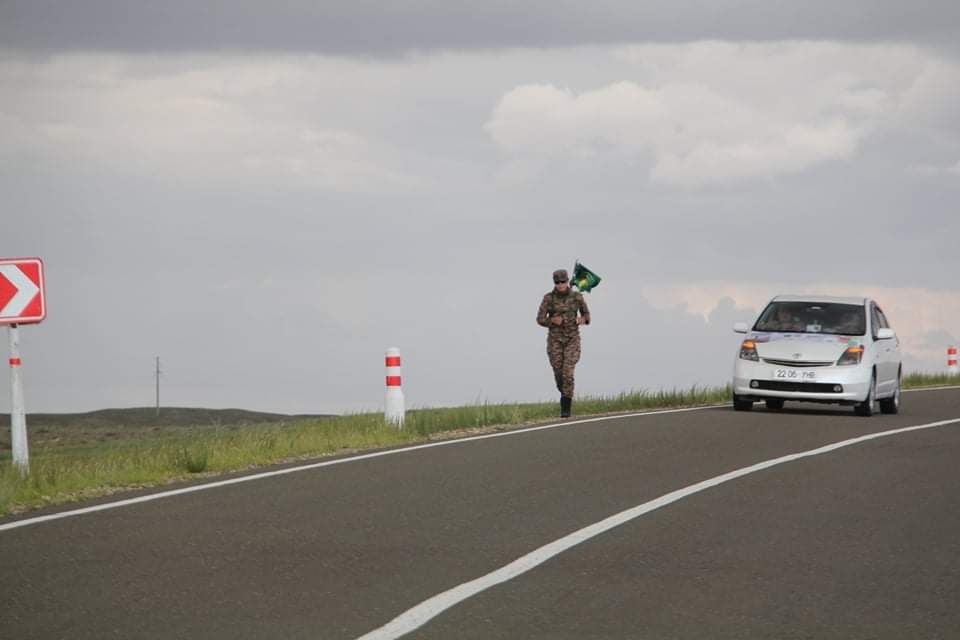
[358,418,960,640]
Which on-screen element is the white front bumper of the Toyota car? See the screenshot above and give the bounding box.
[733,359,872,404]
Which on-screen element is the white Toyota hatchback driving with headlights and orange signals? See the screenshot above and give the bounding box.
[733,296,903,416]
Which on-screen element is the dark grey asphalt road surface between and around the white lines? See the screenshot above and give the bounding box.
[0,390,960,640]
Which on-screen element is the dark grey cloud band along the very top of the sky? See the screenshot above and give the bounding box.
[0,0,960,56]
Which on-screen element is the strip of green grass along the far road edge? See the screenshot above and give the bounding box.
[0,373,958,516]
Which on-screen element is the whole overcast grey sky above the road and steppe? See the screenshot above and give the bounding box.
[0,0,960,413]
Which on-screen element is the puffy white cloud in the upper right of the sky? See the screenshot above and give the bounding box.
[486,42,957,187]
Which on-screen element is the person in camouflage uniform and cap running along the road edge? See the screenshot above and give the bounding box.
[537,269,590,418]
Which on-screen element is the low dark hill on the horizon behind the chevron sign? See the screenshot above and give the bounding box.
[0,407,332,429]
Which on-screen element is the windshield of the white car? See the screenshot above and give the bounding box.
[753,302,867,336]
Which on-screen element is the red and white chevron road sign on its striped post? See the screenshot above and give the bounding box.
[0,258,47,474]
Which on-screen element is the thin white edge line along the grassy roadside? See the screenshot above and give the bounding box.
[0,404,727,531]
